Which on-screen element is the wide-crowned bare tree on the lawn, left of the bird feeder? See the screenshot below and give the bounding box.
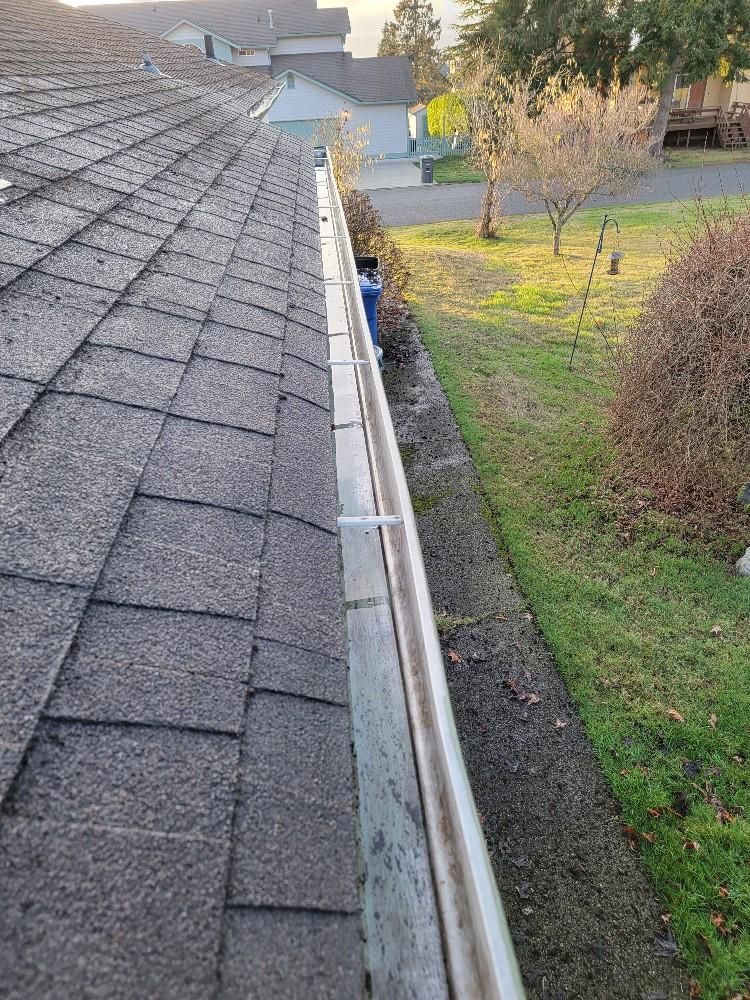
[500,73,658,255]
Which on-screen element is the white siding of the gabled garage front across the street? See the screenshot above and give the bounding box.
[268,75,409,156]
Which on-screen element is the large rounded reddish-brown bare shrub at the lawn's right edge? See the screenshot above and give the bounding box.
[612,212,750,528]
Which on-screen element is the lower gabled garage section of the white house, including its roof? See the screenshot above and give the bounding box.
[268,52,416,157]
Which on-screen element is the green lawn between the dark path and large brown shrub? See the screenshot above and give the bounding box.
[394,199,750,1000]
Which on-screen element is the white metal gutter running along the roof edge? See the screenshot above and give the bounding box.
[316,161,525,1000]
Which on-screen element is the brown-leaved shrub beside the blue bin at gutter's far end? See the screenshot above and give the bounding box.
[342,191,410,331]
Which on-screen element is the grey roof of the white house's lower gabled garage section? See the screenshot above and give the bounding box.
[271,52,417,104]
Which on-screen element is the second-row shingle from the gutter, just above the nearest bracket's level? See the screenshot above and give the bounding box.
[141,417,273,515]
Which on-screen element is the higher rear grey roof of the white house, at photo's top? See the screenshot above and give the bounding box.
[81,0,351,48]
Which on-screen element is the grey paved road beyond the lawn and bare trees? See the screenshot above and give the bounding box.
[370,163,750,226]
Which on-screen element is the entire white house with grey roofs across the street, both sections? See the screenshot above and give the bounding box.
[87,0,424,157]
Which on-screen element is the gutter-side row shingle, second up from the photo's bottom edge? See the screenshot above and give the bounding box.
[229,693,358,912]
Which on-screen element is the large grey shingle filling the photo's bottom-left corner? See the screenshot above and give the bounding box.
[0,818,227,1000]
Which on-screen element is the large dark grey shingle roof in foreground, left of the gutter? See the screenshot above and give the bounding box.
[0,0,363,1000]
